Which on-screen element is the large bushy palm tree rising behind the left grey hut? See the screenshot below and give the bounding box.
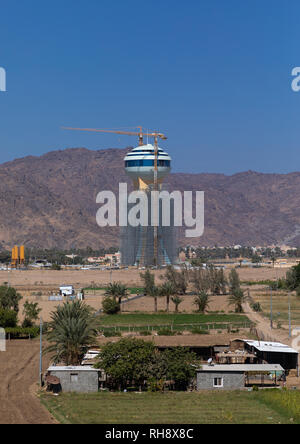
[45,301,98,365]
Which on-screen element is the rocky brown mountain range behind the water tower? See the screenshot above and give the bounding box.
[0,148,300,249]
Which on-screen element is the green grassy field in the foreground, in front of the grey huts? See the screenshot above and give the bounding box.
[41,390,300,424]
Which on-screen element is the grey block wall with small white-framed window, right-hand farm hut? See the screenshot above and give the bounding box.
[197,372,245,390]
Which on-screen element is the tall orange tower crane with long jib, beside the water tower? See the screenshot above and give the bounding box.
[63,126,168,266]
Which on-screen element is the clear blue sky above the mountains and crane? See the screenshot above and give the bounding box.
[0,0,300,174]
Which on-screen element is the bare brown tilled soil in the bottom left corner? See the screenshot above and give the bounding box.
[0,341,54,424]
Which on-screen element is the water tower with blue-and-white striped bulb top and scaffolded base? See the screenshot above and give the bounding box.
[121,144,177,267]
